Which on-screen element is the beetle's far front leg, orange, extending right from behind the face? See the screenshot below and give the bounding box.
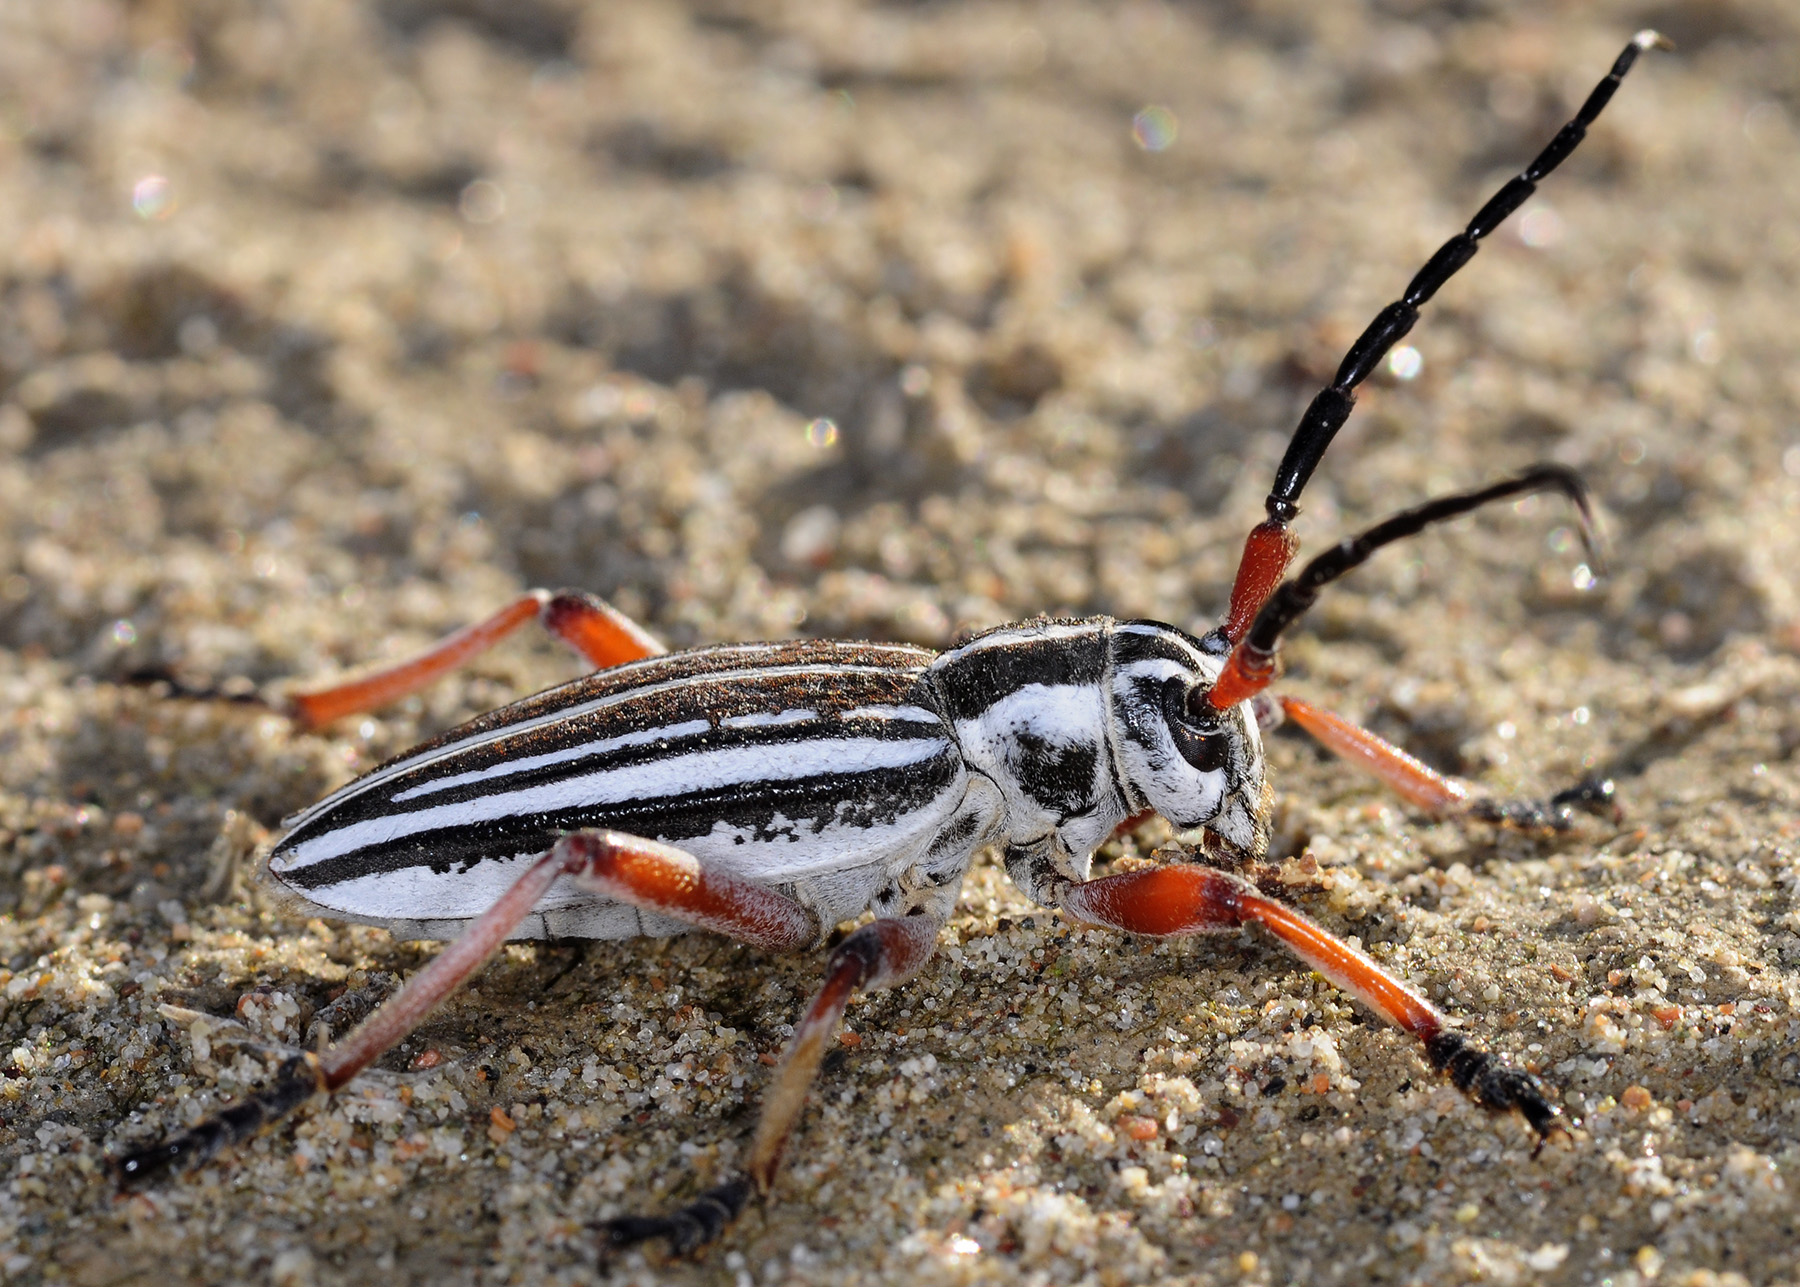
[1280,697,1618,832]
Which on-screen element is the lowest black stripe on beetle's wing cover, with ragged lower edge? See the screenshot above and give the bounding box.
[279,747,961,889]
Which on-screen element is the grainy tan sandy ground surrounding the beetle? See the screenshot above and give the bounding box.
[0,0,1800,1285]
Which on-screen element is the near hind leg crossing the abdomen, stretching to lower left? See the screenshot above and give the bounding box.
[119,832,824,1183]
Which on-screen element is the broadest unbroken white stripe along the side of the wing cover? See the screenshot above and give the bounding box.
[270,738,950,871]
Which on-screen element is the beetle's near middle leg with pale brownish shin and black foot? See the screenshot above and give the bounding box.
[599,914,943,1255]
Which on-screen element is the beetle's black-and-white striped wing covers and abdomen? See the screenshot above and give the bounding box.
[270,643,965,936]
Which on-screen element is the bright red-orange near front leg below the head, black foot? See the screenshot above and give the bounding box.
[1062,864,1562,1138]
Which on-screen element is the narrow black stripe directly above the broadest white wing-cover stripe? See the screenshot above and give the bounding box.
[277,720,949,842]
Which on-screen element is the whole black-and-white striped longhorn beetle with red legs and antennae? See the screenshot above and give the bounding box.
[119,31,1665,1251]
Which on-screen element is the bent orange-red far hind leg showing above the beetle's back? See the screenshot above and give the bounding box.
[288,590,668,729]
